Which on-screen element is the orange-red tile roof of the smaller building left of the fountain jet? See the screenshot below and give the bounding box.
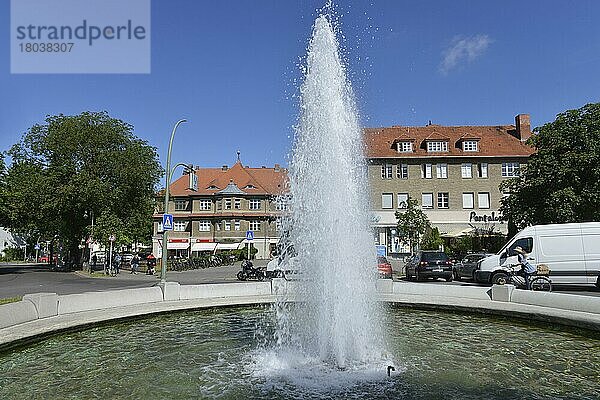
[170,161,287,196]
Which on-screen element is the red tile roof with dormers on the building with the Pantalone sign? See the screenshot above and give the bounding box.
[364,125,534,158]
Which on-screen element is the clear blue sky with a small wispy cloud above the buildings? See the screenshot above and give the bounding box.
[0,0,600,167]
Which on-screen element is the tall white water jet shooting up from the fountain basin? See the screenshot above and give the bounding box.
[270,15,383,370]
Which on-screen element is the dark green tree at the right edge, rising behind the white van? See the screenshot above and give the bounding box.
[500,103,600,229]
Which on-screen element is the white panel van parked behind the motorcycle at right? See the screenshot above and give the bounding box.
[475,222,600,287]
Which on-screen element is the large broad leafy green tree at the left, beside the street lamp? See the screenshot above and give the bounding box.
[0,112,162,264]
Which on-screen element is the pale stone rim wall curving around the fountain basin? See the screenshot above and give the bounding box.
[0,279,600,348]
